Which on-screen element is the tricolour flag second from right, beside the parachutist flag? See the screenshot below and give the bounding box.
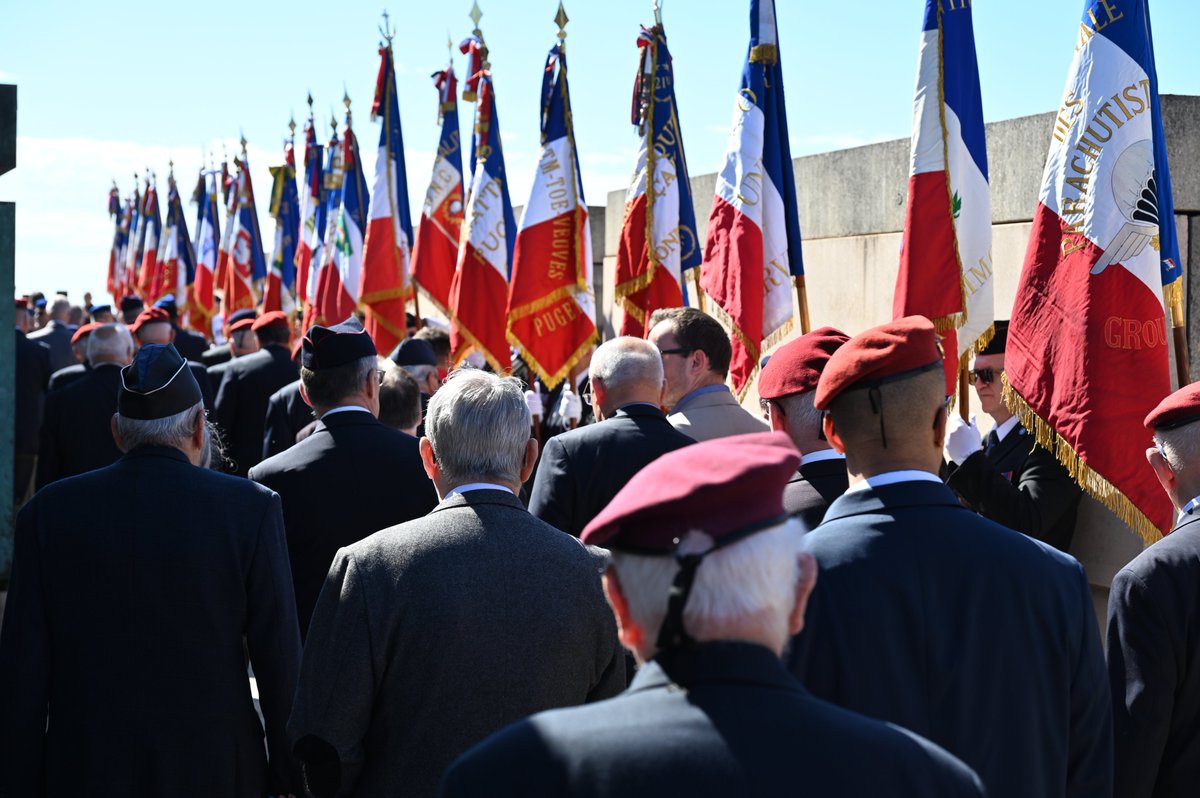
[893,0,996,386]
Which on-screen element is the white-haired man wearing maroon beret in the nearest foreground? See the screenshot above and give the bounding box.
[443,432,983,798]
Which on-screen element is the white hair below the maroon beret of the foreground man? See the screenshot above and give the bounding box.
[612,518,805,657]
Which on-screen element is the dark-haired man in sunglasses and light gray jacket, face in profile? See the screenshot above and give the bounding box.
[647,307,770,440]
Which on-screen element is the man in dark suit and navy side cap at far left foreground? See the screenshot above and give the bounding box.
[0,343,300,798]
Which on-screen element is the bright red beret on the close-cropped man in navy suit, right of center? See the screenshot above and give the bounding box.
[812,316,942,410]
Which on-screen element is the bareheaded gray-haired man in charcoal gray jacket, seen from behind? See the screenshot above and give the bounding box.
[288,370,625,798]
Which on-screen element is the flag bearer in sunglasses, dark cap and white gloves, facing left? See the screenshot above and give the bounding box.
[946,320,1082,551]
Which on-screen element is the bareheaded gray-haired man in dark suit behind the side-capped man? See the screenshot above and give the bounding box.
[37,324,133,490]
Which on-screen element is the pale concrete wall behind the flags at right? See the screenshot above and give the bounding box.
[598,95,1200,618]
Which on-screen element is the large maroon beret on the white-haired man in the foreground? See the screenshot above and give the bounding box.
[581,432,800,554]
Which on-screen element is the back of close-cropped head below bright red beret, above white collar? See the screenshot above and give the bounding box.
[824,368,946,476]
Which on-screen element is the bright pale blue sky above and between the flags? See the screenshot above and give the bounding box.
[0,0,1200,299]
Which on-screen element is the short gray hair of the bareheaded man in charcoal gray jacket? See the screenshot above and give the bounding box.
[425,368,533,486]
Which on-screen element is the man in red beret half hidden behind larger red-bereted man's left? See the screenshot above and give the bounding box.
[758,326,850,529]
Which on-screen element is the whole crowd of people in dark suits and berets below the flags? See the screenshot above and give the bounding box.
[0,295,1200,798]
